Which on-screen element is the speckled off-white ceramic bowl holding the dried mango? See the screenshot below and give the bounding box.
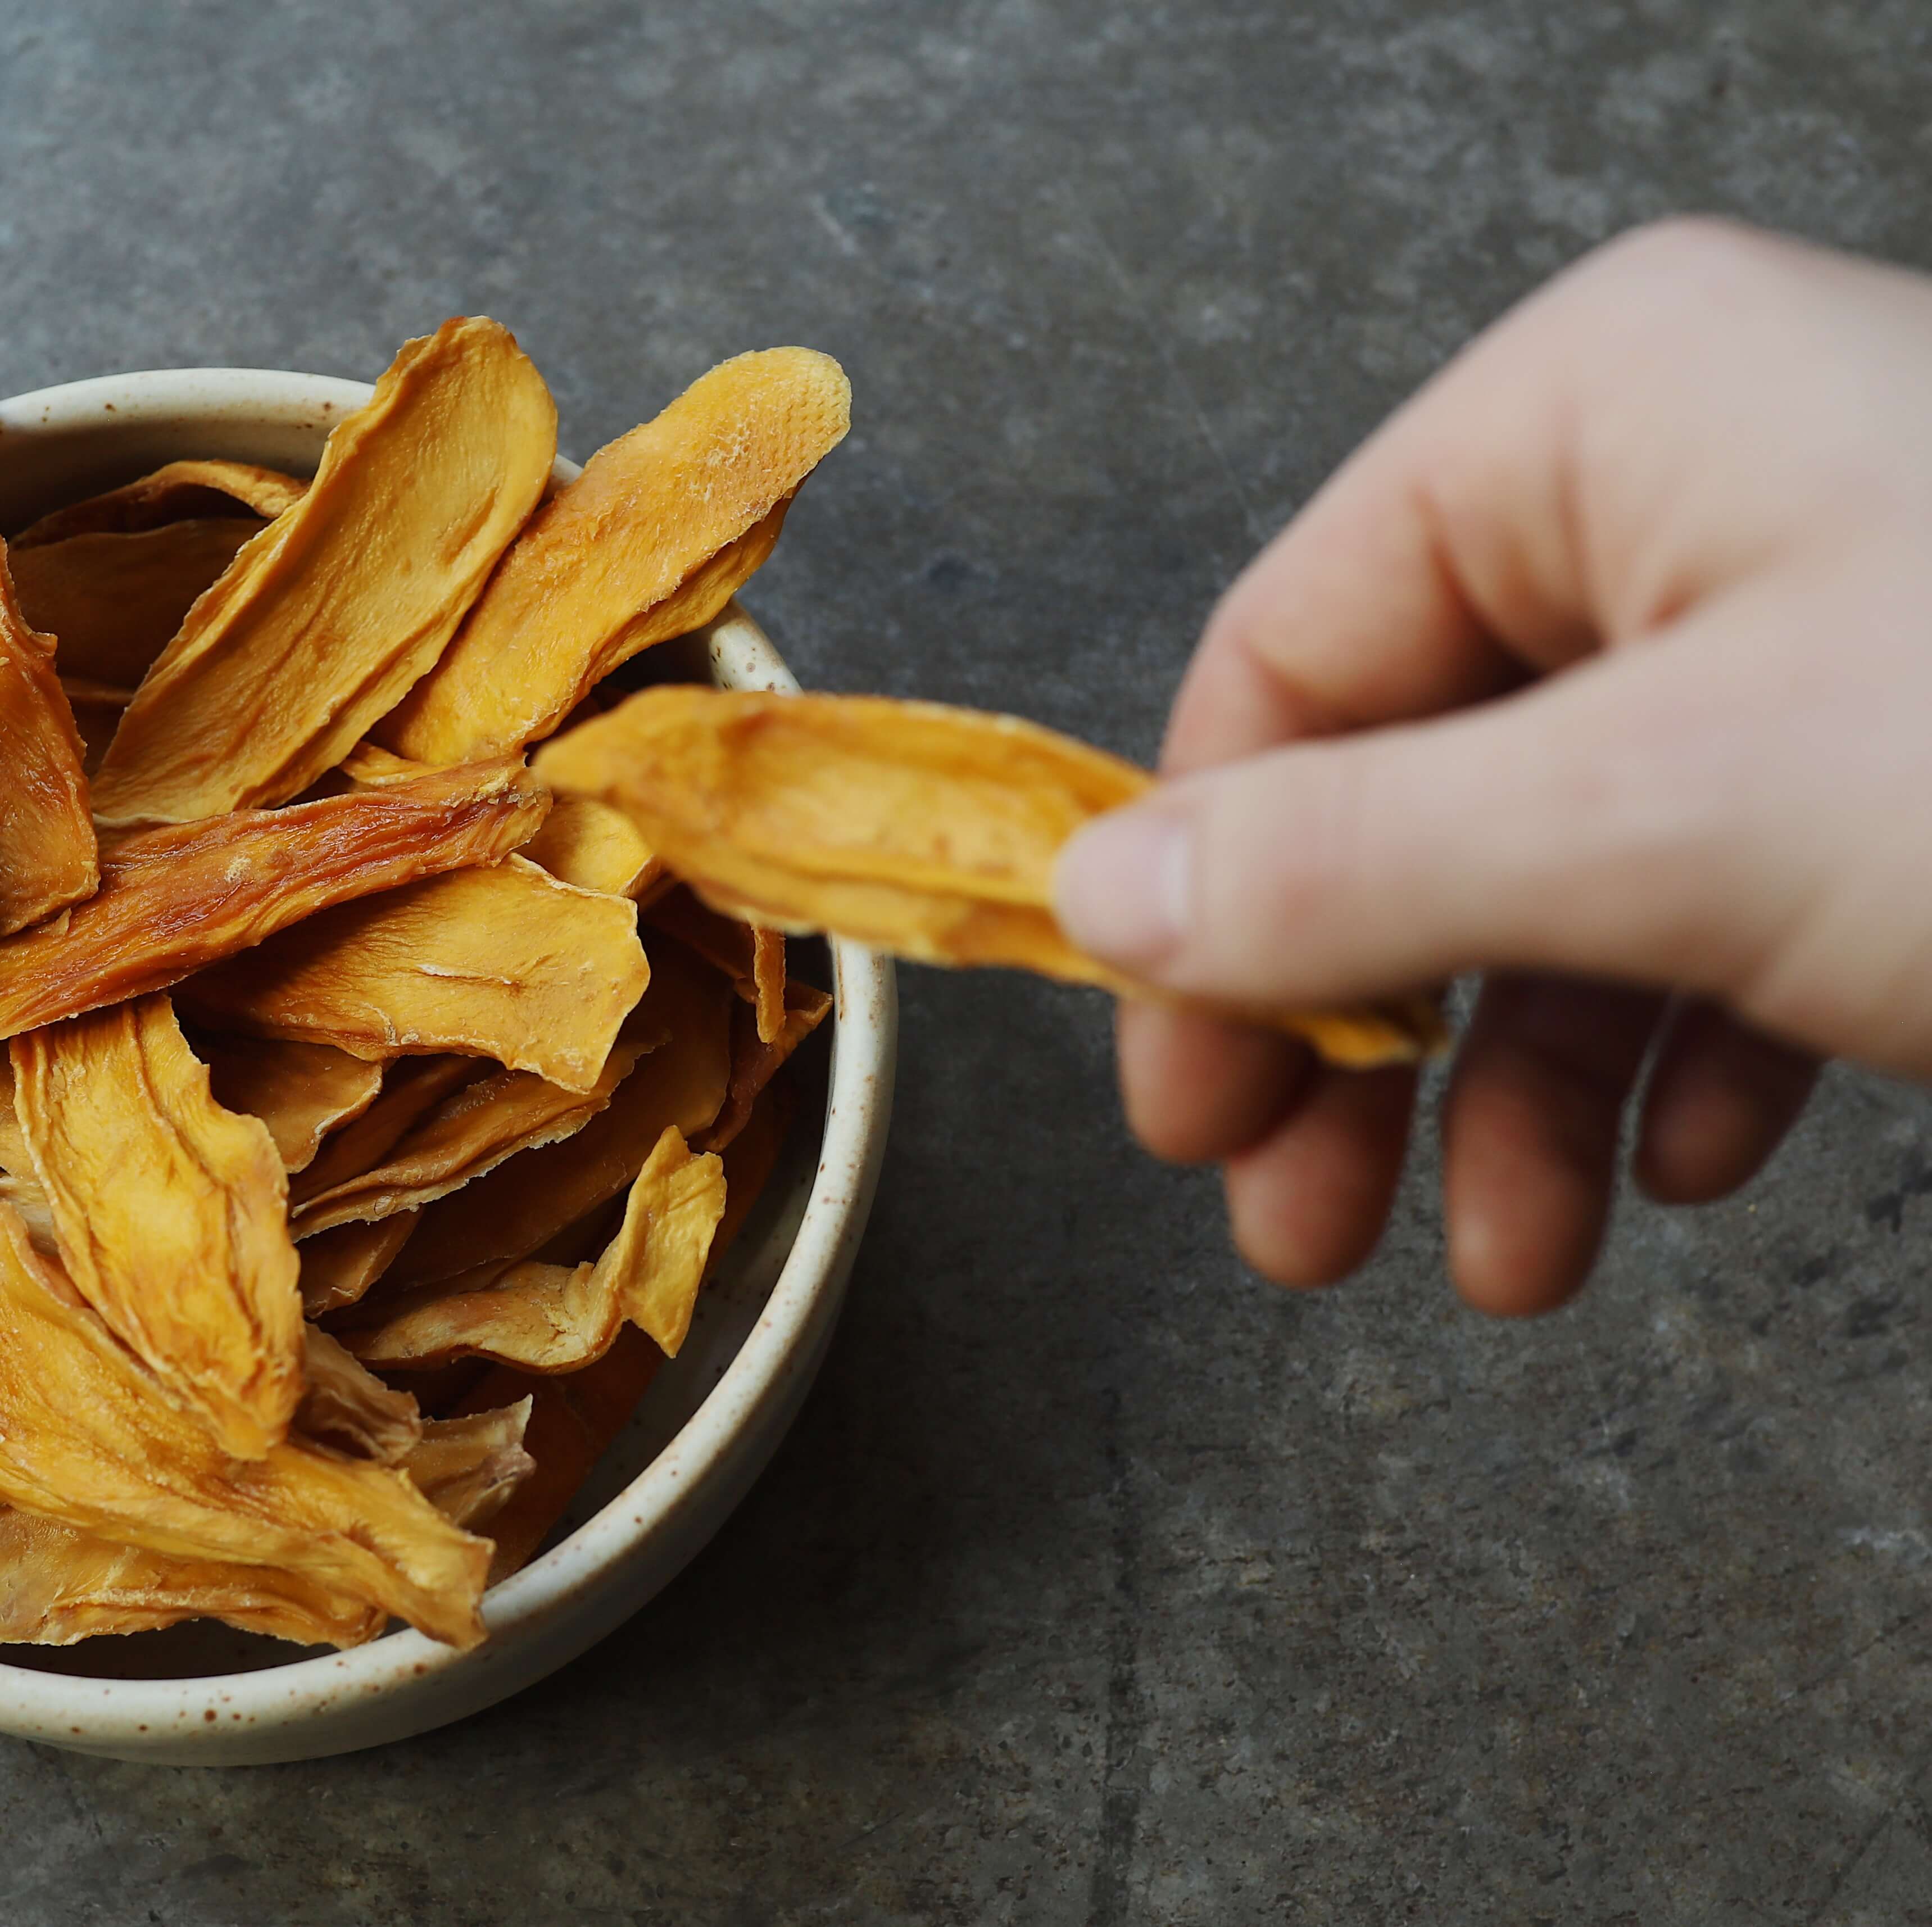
[0,367,896,1767]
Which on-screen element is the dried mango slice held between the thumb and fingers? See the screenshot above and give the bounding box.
[535,684,1441,1067]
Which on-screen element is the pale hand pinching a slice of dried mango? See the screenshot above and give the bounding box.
[1059,223,1932,1312]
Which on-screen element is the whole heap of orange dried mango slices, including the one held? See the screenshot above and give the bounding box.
[0,319,1437,1645]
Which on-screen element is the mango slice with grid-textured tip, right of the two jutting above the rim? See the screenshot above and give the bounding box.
[377,348,852,764]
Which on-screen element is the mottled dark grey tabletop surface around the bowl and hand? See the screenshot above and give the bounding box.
[0,0,1932,1927]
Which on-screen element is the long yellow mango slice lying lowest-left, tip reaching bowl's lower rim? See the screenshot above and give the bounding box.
[0,1208,502,1647]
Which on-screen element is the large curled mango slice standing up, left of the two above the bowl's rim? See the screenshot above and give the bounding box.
[94,319,556,823]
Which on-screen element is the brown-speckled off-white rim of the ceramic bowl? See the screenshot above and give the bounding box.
[0,367,896,1749]
